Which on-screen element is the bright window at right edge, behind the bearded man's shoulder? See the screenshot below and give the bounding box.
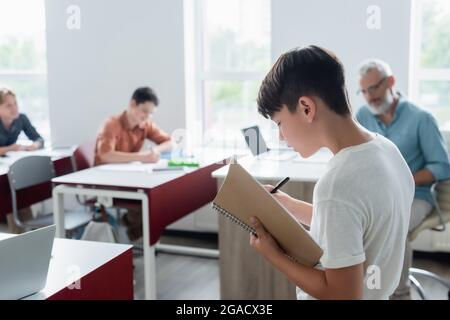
[411,0,450,131]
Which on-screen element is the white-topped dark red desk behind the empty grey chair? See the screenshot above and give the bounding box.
[0,148,73,220]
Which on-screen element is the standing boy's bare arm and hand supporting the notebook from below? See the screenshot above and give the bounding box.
[250,218,364,299]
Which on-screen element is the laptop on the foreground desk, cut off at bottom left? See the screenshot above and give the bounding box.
[0,225,56,300]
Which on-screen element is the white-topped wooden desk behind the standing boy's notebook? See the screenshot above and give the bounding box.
[213,151,332,299]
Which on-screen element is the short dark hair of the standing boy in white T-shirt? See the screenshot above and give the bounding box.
[257,46,351,118]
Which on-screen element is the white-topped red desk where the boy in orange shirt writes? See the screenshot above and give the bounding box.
[52,150,232,299]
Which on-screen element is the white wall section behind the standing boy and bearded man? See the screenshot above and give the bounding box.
[272,0,411,110]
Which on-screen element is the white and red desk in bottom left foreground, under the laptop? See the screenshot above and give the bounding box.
[0,233,133,300]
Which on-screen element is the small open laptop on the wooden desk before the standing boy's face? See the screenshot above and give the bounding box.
[241,126,297,161]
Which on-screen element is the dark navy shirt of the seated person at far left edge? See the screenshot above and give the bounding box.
[0,113,44,147]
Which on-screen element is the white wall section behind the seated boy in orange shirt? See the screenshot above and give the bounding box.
[46,0,185,146]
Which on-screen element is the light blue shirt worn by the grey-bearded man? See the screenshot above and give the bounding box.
[356,97,450,206]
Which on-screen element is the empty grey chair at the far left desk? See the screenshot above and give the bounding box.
[8,156,92,233]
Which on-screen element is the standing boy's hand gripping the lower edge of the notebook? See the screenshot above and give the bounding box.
[250,217,284,260]
